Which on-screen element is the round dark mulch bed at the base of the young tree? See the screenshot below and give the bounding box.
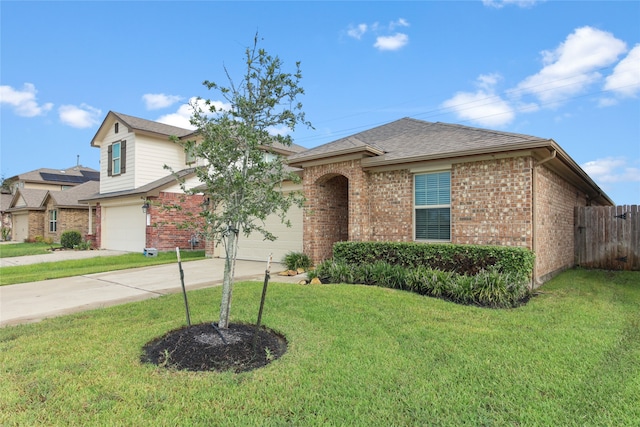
[141,323,287,372]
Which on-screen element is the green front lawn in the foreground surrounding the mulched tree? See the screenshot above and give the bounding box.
[0,270,640,426]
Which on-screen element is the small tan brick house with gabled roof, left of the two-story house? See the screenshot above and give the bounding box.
[8,181,99,242]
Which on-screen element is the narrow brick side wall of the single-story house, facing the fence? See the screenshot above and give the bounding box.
[535,165,587,282]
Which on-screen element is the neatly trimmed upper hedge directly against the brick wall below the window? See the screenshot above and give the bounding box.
[333,242,535,280]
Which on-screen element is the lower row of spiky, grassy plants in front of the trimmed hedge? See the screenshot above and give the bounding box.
[309,260,531,308]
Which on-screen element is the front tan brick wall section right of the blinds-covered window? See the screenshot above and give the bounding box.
[451,157,533,248]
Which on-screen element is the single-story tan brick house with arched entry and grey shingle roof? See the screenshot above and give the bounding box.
[289,118,613,285]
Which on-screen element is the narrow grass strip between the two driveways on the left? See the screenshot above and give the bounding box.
[0,249,205,286]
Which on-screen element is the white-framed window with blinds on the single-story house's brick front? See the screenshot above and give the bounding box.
[413,171,451,241]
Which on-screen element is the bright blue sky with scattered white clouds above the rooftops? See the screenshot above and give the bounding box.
[0,0,640,204]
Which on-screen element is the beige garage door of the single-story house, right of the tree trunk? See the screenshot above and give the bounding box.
[238,206,302,262]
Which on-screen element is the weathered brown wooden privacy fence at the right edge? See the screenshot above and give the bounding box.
[573,205,640,270]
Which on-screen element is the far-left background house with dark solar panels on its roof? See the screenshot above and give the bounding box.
[2,165,100,241]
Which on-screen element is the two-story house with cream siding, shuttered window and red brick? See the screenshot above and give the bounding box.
[84,111,303,259]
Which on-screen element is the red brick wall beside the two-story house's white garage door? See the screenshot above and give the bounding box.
[146,193,205,251]
